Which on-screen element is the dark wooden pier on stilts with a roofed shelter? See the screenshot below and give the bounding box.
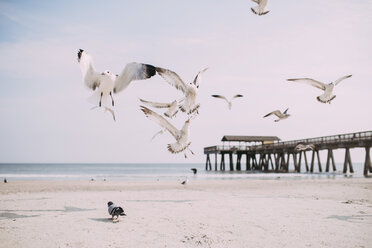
[204,131,372,176]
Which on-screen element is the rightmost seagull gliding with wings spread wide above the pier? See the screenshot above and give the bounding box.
[287,75,352,104]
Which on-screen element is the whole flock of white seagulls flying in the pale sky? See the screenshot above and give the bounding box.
[78,0,352,161]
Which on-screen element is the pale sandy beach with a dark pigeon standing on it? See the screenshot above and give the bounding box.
[0,178,372,248]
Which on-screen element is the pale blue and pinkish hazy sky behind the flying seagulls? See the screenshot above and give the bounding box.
[0,0,372,163]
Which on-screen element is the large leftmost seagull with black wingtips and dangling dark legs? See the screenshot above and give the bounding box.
[78,49,156,107]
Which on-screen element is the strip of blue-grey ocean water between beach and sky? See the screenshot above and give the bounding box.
[0,163,364,181]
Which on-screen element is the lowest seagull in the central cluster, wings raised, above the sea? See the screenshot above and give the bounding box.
[140,106,194,158]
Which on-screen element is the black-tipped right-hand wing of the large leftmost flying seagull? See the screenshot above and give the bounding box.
[114,62,156,93]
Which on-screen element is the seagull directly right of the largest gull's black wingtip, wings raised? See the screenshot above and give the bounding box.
[156,67,208,115]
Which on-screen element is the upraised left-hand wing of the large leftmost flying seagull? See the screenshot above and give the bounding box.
[78,49,101,90]
